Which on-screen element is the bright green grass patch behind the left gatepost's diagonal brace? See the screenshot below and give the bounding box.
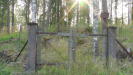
[0,32,27,51]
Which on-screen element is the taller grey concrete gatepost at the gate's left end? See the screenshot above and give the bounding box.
[25,23,37,72]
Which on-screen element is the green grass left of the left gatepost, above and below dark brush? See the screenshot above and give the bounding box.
[0,32,27,75]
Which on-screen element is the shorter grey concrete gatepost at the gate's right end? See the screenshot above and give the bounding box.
[108,26,118,58]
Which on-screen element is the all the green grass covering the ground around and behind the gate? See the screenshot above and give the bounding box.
[0,24,133,75]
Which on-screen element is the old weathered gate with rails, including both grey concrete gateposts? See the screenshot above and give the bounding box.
[26,23,117,74]
